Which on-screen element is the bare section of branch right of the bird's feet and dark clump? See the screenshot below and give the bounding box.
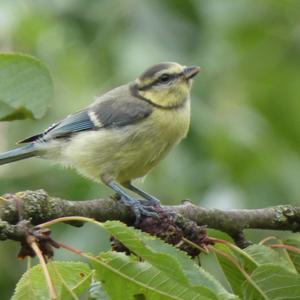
[173,202,300,248]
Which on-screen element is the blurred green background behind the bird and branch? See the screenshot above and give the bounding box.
[0,0,300,299]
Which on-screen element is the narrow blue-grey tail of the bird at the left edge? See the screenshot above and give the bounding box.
[0,144,38,165]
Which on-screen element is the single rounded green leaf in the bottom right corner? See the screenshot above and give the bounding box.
[242,264,300,300]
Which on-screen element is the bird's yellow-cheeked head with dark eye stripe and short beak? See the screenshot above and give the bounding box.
[131,62,200,108]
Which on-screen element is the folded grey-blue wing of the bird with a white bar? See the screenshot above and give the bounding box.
[20,97,153,143]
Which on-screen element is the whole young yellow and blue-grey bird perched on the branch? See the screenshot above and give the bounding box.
[0,62,200,221]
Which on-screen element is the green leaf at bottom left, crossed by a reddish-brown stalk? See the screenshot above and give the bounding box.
[12,262,92,300]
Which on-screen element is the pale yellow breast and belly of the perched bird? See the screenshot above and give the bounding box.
[61,102,189,183]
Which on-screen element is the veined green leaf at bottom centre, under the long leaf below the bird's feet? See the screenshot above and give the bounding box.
[90,252,216,300]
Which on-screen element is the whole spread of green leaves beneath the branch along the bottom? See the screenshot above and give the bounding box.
[12,221,300,300]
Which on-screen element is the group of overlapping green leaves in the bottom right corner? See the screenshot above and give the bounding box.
[213,234,300,300]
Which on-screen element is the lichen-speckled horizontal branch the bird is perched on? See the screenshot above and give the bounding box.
[0,190,300,246]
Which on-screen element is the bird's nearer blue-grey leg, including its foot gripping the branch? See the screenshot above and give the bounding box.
[103,180,157,225]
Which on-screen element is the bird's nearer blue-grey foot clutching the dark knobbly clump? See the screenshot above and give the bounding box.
[120,196,158,226]
